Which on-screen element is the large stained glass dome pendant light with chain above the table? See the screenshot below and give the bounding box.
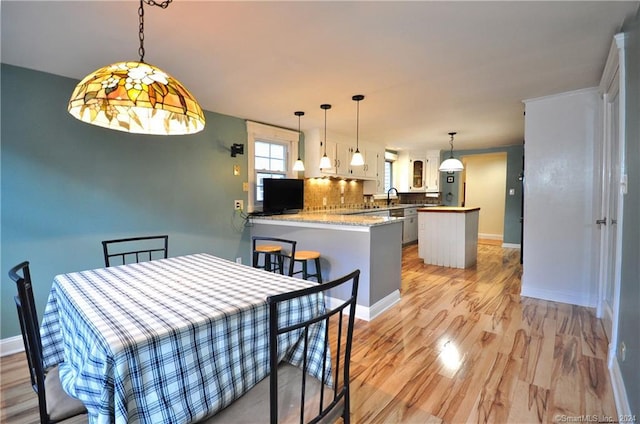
[68,0,205,135]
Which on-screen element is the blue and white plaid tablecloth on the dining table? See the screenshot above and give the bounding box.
[40,254,330,424]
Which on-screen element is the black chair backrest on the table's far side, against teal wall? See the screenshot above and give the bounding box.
[102,235,169,267]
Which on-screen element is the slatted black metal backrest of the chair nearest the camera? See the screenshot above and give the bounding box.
[267,270,360,424]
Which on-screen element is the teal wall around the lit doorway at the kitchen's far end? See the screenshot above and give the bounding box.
[440,145,524,244]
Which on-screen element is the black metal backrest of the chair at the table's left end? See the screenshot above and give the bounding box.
[9,261,49,423]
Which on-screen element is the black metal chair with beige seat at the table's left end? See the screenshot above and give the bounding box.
[9,261,87,423]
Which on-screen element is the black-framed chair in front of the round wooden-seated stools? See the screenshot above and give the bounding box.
[251,236,296,277]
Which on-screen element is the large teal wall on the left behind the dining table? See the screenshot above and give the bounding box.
[0,64,250,338]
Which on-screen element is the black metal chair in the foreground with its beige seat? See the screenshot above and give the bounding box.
[206,270,360,424]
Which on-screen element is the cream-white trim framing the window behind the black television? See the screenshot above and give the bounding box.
[247,121,300,212]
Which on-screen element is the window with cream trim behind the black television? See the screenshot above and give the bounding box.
[247,121,300,212]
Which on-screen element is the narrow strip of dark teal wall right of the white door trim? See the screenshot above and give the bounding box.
[618,11,640,414]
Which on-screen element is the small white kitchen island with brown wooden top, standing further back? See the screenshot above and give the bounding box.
[418,206,480,268]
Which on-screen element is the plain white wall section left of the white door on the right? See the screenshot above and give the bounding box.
[522,88,601,307]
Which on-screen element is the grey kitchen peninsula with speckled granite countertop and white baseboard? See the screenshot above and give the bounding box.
[250,213,403,321]
